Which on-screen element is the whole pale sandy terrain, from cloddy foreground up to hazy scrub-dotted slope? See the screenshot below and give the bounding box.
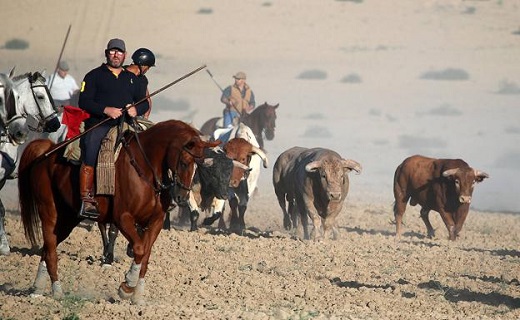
[0,0,520,320]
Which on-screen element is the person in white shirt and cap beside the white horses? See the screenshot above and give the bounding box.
[47,60,79,143]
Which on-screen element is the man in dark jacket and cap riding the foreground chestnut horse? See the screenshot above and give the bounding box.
[79,39,149,220]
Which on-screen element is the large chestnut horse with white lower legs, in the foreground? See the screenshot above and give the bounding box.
[18,120,220,304]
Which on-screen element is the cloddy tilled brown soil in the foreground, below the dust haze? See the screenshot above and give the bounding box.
[0,190,520,320]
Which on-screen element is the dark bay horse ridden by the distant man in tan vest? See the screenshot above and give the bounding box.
[200,102,279,149]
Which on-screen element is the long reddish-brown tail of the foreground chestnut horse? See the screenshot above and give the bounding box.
[18,140,54,246]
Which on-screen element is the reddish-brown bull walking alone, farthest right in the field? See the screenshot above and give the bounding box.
[394,155,489,240]
